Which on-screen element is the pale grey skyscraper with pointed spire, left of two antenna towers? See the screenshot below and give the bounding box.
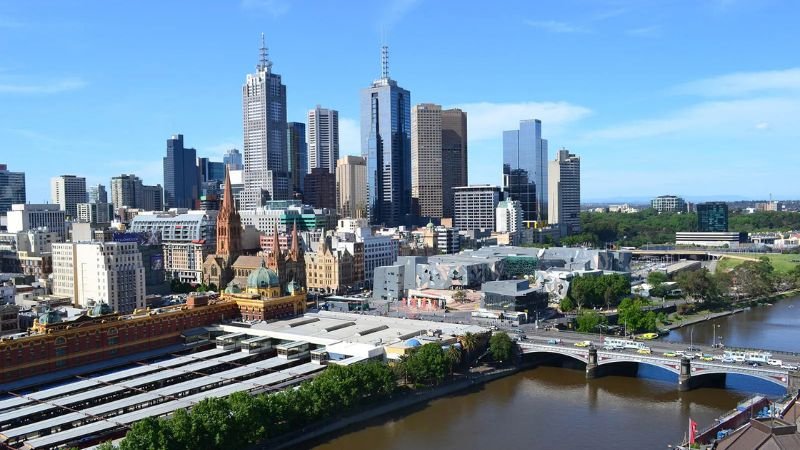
[242,34,289,209]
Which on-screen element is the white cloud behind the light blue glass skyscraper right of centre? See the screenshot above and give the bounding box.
[450,102,592,142]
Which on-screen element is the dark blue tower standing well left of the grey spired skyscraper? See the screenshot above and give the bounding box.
[162,134,200,209]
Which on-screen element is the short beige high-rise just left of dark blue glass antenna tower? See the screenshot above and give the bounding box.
[336,156,367,219]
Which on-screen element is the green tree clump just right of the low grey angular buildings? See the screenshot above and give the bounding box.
[560,274,631,311]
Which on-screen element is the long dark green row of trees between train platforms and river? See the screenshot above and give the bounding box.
[100,362,397,450]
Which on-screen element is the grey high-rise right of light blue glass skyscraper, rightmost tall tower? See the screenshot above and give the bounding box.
[547,148,581,236]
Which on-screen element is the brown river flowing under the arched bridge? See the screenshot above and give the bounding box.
[301,297,800,450]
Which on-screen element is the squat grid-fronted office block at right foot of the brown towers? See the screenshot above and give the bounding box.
[453,185,500,230]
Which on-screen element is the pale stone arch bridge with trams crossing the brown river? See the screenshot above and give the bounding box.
[517,332,800,392]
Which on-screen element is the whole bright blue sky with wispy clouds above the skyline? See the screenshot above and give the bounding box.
[0,0,800,202]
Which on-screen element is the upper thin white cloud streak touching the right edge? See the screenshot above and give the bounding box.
[674,67,800,97]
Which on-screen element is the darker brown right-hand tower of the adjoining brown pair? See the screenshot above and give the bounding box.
[442,109,469,217]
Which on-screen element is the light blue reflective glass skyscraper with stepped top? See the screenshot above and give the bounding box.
[503,119,548,222]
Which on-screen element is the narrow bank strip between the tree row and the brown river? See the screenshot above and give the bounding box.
[258,367,519,450]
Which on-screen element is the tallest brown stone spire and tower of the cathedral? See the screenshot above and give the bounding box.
[203,167,242,291]
